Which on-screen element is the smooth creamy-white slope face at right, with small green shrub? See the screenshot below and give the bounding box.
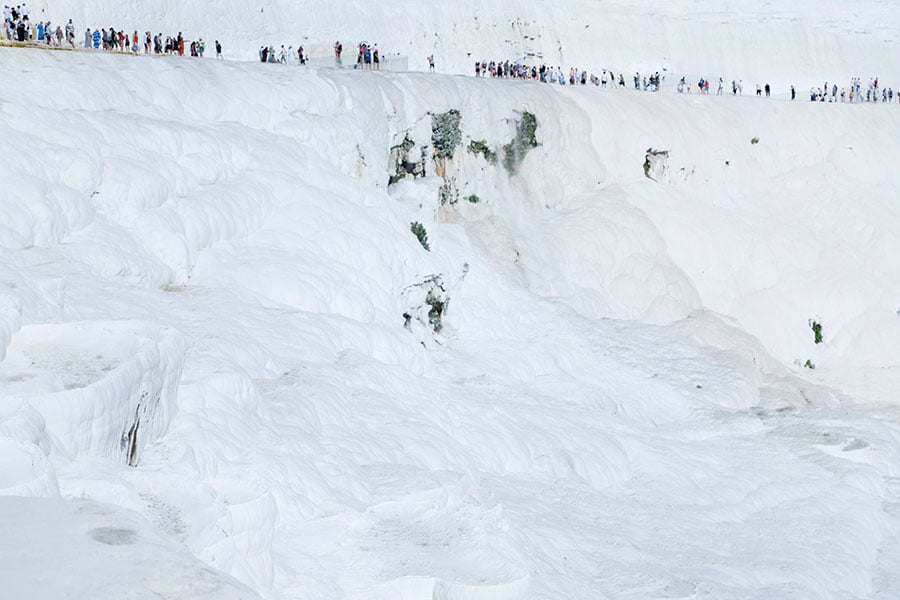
[567,89,900,374]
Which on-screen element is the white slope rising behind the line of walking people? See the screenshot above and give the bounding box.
[30,0,900,87]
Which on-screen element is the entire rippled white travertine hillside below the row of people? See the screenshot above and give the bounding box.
[0,39,900,599]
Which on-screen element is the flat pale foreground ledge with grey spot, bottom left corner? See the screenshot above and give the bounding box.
[0,497,259,600]
